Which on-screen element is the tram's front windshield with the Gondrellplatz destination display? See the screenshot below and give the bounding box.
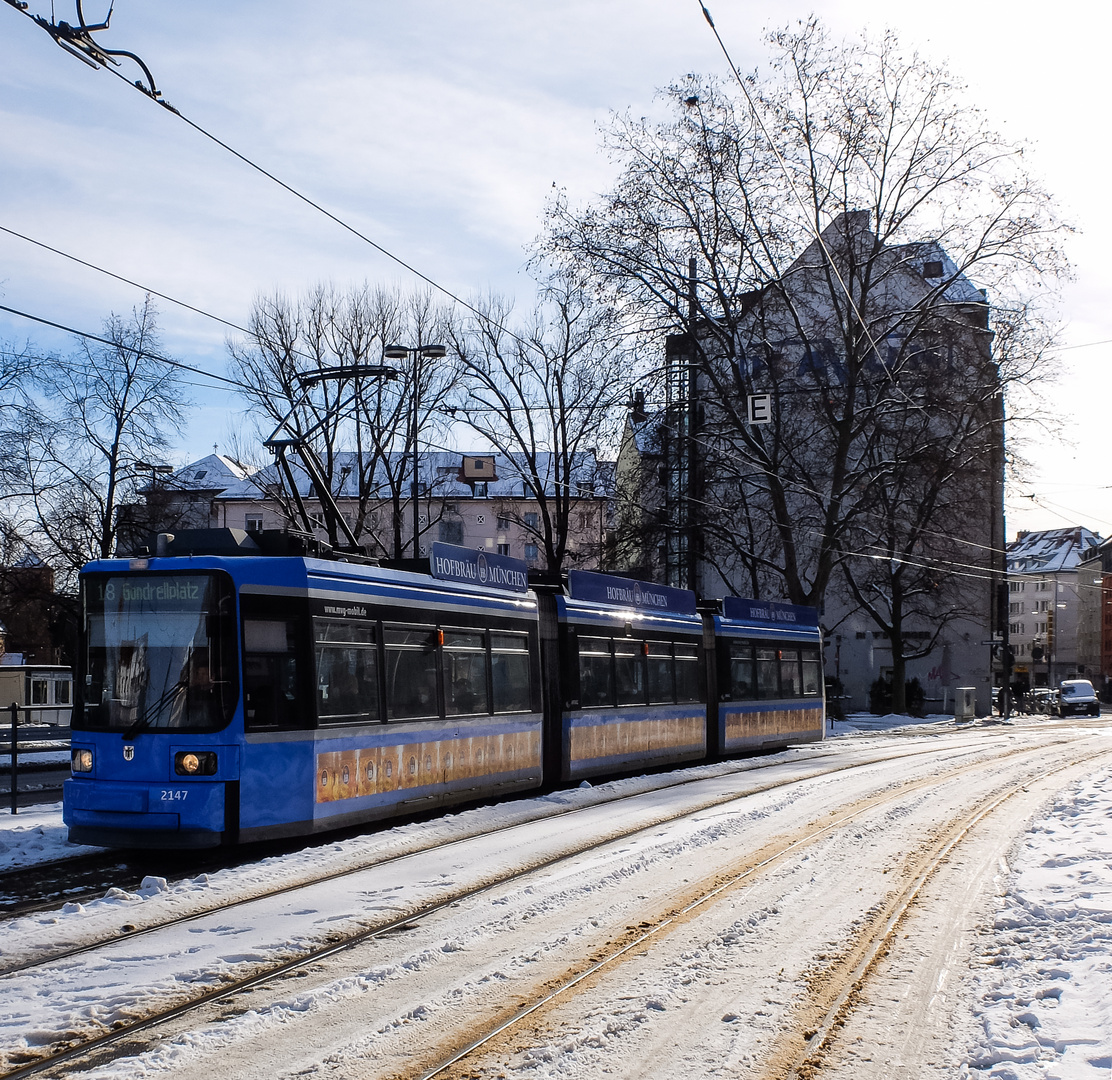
[73,574,238,737]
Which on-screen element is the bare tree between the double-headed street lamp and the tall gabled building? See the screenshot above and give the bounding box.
[450,276,634,572]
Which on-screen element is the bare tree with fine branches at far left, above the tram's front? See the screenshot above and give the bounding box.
[19,297,189,585]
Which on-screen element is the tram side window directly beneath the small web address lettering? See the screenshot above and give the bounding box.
[312,618,381,723]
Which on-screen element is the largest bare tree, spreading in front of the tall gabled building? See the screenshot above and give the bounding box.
[540,20,1066,622]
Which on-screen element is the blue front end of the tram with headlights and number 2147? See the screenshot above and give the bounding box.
[62,559,240,848]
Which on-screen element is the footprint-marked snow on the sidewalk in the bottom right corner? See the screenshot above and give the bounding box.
[960,771,1112,1080]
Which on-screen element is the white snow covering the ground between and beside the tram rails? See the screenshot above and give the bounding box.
[0,717,1112,1080]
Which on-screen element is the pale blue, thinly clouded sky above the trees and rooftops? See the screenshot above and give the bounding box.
[0,0,1112,536]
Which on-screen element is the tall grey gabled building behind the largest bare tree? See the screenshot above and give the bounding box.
[617,210,1004,714]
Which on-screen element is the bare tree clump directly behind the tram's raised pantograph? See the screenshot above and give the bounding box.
[228,285,454,557]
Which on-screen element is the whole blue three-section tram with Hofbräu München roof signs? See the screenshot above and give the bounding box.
[63,529,823,848]
